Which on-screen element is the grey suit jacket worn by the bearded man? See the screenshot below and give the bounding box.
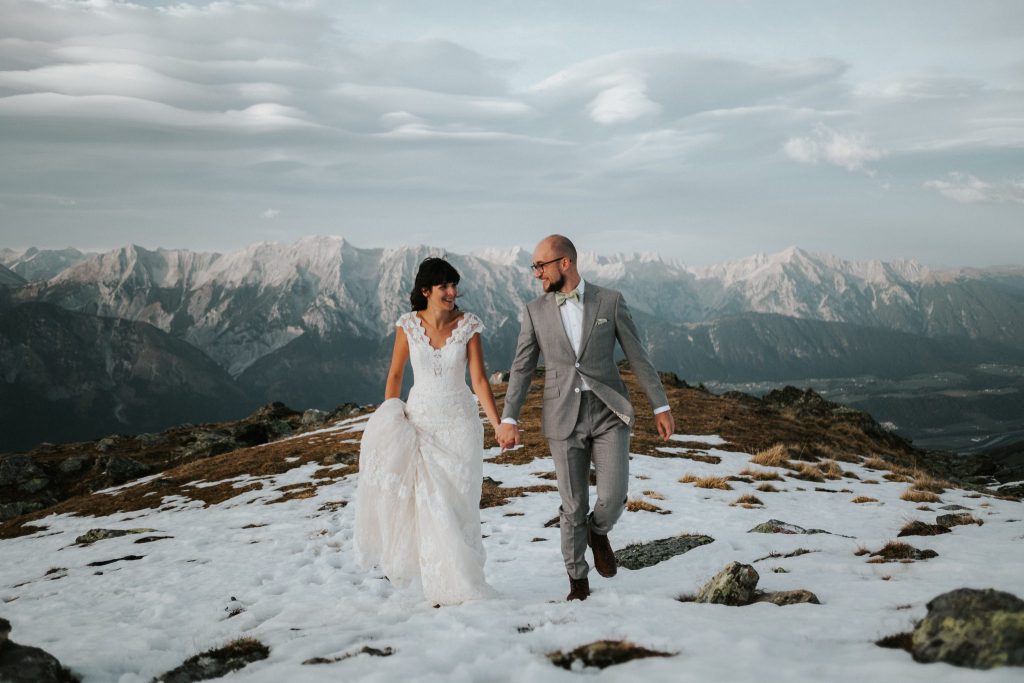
[502,281,669,439]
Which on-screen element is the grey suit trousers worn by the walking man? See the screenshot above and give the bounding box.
[548,391,630,579]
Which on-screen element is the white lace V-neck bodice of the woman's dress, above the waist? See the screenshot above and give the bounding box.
[395,311,483,393]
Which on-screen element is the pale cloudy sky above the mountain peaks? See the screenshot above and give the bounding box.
[0,0,1024,265]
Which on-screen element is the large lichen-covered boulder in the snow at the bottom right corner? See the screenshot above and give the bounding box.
[913,588,1024,669]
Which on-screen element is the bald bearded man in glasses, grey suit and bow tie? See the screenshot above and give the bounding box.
[498,234,676,600]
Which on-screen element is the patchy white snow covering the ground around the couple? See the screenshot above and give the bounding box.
[0,423,1024,683]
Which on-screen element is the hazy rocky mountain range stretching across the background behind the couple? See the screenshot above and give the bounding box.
[0,236,1024,450]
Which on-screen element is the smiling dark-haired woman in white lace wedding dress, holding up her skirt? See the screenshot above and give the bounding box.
[355,258,499,605]
